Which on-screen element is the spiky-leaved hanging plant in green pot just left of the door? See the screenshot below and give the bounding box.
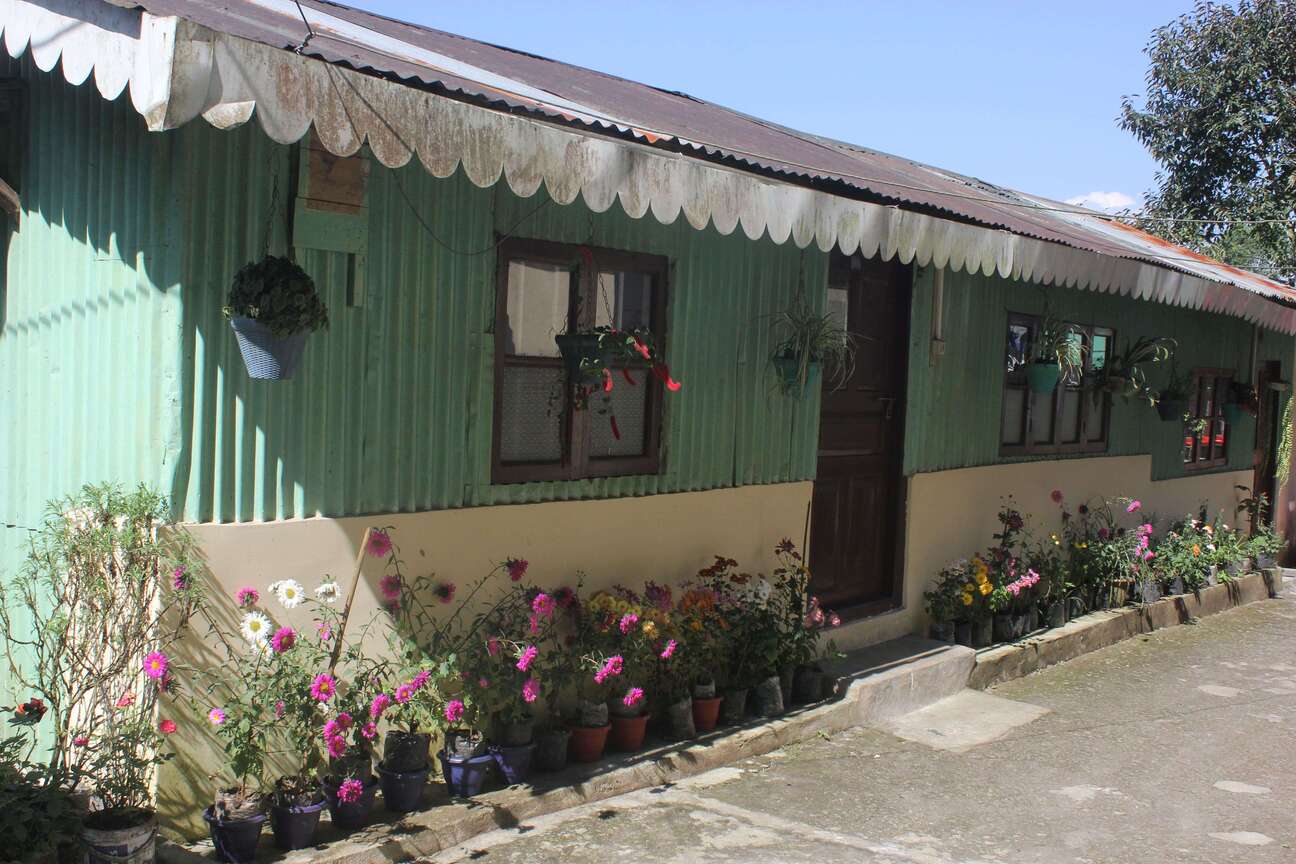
[770,294,855,396]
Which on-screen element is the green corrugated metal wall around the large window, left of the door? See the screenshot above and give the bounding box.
[174,105,827,521]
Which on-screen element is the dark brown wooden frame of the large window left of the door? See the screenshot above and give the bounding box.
[491,238,670,484]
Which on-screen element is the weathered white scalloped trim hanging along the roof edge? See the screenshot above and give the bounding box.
[0,0,1296,333]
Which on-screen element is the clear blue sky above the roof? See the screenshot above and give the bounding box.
[350,0,1191,211]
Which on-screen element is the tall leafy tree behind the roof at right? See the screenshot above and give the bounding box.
[1120,0,1296,284]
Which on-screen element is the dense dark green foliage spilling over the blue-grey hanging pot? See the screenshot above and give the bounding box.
[224,255,328,338]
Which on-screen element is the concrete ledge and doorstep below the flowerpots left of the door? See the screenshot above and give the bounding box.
[158,636,975,864]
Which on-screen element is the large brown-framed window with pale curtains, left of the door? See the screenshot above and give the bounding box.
[491,240,667,483]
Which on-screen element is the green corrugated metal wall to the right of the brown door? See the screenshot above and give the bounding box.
[905,267,1293,479]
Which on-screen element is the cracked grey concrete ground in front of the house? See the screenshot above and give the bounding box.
[430,591,1296,864]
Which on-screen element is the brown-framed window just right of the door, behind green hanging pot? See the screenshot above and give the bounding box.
[999,312,1115,456]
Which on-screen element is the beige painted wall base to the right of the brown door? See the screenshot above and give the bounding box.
[831,456,1252,650]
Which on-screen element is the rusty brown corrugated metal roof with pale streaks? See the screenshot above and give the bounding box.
[27,0,1296,314]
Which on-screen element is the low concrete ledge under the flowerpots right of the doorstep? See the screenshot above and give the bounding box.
[967,569,1282,690]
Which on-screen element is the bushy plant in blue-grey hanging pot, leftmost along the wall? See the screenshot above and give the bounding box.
[224,255,328,381]
